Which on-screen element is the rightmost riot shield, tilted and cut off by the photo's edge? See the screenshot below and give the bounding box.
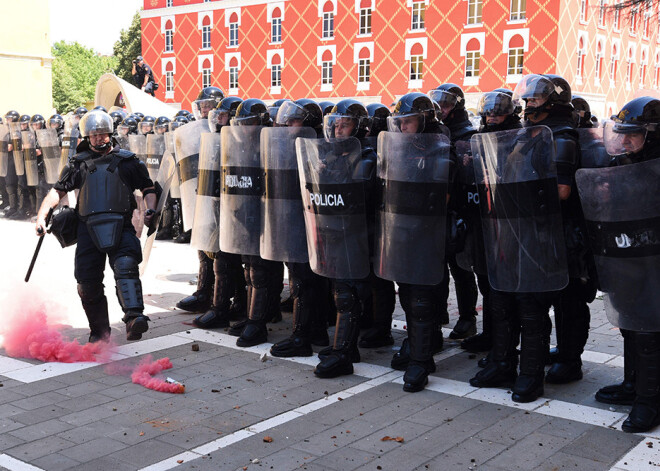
[576,159,660,332]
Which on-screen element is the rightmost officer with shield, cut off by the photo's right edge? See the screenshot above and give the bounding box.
[577,96,660,433]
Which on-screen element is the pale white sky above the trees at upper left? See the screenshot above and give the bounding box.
[48,0,144,55]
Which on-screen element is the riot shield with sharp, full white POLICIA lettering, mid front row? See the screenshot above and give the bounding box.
[296,137,369,279]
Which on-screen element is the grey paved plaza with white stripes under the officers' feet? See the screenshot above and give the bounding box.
[0,220,660,471]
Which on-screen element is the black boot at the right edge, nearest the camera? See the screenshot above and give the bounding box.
[621,332,660,433]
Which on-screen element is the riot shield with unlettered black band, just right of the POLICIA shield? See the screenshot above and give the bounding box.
[374,132,450,285]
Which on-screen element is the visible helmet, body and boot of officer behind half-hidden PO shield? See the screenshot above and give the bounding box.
[429,83,480,339]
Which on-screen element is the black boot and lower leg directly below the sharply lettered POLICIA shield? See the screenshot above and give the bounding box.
[314,283,361,378]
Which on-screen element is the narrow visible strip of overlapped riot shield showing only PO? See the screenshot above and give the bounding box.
[453,141,488,275]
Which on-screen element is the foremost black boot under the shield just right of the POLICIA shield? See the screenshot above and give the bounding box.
[403,318,438,392]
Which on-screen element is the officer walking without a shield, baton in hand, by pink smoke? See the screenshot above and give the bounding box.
[36,111,157,342]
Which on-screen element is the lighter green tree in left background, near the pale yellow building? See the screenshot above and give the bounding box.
[52,41,117,113]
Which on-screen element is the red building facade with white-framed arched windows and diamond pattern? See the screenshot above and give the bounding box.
[142,0,660,116]
